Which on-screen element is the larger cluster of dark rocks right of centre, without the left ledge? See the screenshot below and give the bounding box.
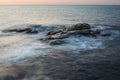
[40,23,111,45]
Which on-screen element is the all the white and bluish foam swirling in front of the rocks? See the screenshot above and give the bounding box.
[0,26,119,63]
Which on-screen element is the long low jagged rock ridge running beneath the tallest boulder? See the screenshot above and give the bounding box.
[40,29,101,41]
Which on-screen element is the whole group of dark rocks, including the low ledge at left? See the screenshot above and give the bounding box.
[3,23,111,45]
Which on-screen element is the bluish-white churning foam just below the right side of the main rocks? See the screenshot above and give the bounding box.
[52,36,103,51]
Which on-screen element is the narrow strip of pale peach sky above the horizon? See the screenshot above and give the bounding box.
[0,0,120,5]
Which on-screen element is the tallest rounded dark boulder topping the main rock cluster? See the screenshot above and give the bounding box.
[67,23,90,31]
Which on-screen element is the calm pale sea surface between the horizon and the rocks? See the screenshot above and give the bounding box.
[0,5,120,28]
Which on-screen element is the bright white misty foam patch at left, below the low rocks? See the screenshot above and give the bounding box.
[0,44,49,63]
